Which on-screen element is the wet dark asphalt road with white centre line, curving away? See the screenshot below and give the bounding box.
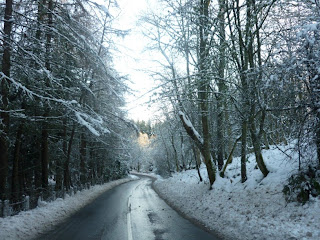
[38,177,218,240]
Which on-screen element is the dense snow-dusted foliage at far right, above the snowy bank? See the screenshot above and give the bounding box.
[268,1,320,168]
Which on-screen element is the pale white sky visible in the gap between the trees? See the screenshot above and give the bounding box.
[110,0,159,121]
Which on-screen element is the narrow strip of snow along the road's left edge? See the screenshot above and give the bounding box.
[0,175,137,240]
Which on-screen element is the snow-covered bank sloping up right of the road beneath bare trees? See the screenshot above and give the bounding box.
[155,144,320,240]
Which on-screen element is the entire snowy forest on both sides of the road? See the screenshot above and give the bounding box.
[0,0,320,218]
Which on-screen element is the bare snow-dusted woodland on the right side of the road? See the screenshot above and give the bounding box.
[133,0,320,199]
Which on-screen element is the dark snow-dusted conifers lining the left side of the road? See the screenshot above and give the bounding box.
[0,0,131,216]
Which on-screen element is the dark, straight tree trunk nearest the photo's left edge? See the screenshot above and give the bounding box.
[0,0,13,201]
